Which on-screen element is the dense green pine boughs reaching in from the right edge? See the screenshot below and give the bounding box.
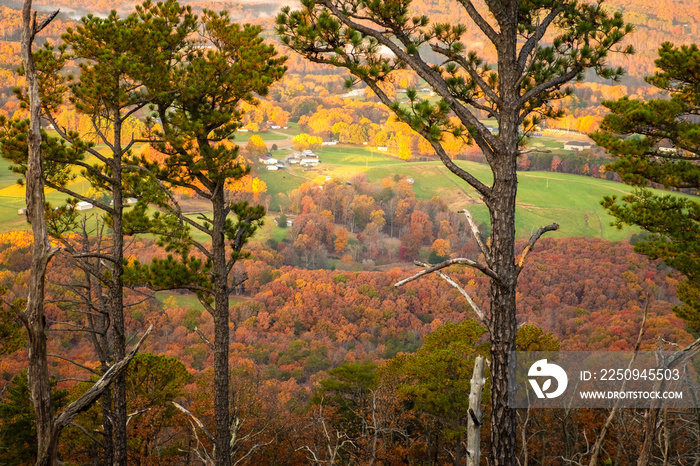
[592,43,700,334]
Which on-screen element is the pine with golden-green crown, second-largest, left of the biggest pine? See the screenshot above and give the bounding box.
[130,11,286,465]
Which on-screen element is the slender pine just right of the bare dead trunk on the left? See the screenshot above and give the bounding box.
[3,1,194,465]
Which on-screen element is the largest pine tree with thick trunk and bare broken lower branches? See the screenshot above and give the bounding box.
[277,0,632,465]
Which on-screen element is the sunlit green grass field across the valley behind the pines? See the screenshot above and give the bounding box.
[0,139,696,241]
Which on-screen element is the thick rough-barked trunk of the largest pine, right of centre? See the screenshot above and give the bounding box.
[487,35,520,458]
